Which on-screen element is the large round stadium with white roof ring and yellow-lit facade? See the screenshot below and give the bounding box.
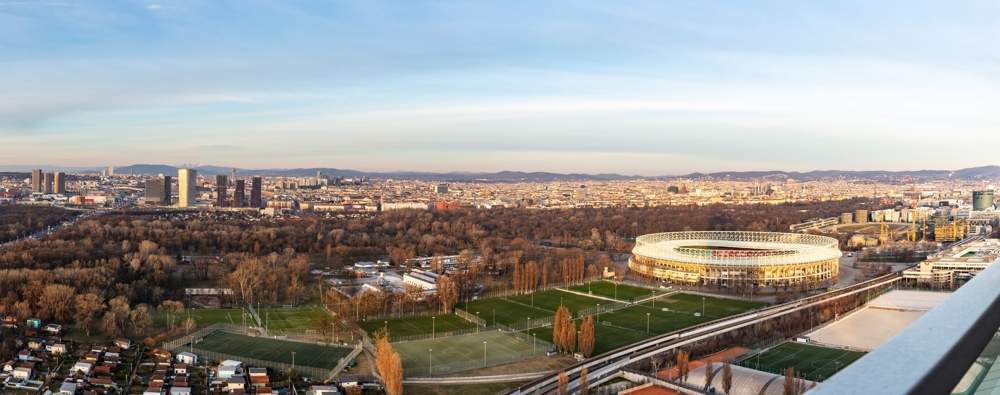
[629,232,841,289]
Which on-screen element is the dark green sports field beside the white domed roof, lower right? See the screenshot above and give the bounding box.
[740,343,865,381]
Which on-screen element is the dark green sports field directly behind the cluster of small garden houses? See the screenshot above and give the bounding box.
[194,331,351,369]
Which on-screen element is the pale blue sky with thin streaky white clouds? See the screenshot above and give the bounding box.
[0,0,1000,175]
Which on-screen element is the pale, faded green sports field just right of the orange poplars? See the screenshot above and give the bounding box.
[392,330,549,376]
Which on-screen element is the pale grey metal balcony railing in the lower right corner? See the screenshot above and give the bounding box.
[809,259,1000,395]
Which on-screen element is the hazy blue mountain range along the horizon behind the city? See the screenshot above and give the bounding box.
[0,164,1000,182]
